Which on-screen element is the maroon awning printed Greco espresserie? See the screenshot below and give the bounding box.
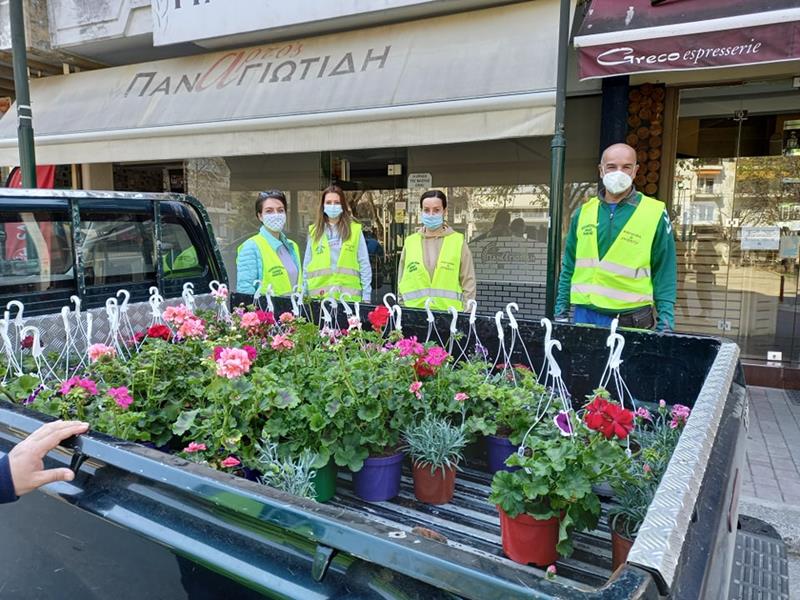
[575,0,800,80]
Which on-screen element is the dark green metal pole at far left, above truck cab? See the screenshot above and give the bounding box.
[9,0,36,188]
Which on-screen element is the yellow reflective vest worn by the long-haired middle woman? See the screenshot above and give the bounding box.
[306,223,362,301]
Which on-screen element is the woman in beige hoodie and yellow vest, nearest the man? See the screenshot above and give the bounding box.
[398,190,475,311]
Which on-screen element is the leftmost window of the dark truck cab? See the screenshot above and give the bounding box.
[0,210,74,295]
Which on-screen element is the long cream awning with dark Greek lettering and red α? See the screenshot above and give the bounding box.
[0,0,558,165]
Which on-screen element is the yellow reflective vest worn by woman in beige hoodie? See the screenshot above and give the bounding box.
[397,233,464,311]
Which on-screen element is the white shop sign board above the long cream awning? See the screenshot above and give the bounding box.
[152,0,431,46]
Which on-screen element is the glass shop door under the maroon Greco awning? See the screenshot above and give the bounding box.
[673,96,800,361]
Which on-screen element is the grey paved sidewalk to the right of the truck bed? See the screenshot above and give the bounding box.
[739,386,800,600]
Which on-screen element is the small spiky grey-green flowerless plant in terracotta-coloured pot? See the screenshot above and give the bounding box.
[403,414,467,504]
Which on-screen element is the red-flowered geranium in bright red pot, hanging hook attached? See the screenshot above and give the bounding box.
[489,403,633,566]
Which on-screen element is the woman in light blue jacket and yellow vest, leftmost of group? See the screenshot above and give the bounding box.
[236,190,303,296]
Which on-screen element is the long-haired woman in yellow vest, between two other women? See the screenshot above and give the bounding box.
[303,185,372,302]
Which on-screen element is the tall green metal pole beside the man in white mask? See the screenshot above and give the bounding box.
[545,0,570,319]
